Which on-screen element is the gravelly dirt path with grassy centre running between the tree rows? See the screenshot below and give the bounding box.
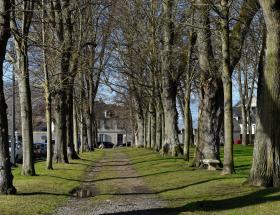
[54,150,168,215]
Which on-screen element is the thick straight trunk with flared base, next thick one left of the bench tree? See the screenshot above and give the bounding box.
[162,0,181,156]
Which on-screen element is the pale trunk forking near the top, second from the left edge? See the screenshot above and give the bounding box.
[11,1,36,175]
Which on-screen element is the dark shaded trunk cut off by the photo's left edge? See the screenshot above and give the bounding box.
[0,0,16,194]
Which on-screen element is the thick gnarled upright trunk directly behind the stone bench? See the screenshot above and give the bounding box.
[191,0,224,167]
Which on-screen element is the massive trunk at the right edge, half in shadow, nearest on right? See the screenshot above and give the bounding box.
[248,0,280,187]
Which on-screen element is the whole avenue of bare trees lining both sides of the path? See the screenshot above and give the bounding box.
[0,0,280,194]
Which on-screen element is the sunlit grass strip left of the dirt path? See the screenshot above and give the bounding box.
[0,150,103,215]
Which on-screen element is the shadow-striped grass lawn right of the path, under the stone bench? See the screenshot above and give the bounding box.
[123,145,280,215]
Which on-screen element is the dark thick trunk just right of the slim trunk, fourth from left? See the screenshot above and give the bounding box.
[49,0,73,163]
